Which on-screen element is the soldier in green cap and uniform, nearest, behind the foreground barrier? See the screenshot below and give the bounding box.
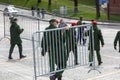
[41,19,67,80]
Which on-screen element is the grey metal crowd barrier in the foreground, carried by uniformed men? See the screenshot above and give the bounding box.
[32,25,93,80]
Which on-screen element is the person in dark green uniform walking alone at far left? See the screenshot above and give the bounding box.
[8,18,26,59]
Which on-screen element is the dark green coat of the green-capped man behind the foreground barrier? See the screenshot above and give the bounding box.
[41,25,66,62]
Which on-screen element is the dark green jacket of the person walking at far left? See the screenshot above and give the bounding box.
[10,22,23,44]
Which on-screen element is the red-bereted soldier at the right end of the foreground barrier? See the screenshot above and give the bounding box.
[88,21,104,66]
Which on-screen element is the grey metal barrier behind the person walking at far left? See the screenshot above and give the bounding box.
[4,15,40,40]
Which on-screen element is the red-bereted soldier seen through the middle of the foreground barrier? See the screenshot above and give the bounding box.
[66,22,78,65]
